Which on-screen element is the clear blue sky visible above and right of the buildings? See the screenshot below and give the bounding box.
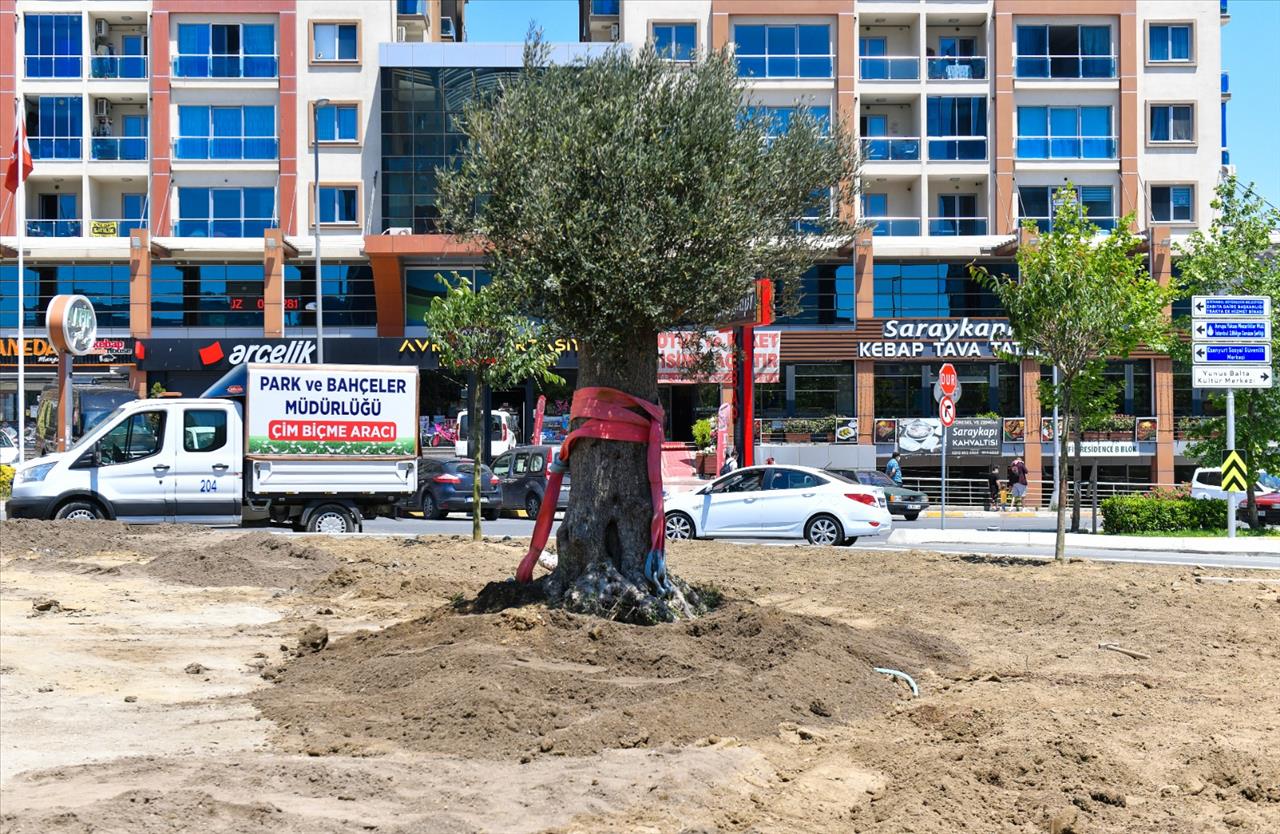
[467,0,1280,206]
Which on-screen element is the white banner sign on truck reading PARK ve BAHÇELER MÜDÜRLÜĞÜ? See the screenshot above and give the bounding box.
[244,365,417,458]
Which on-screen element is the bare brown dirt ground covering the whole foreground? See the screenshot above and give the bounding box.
[0,522,1280,834]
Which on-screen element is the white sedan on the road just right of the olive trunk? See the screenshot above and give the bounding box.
[666,466,893,545]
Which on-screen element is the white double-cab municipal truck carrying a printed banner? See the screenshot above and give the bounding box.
[8,365,419,533]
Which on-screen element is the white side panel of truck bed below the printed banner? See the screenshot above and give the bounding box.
[248,458,417,495]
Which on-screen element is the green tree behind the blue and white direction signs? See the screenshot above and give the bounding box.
[1175,177,1280,516]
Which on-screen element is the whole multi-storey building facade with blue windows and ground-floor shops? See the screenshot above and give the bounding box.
[0,0,1229,501]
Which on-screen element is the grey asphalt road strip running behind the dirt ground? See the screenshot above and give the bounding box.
[365,515,1280,570]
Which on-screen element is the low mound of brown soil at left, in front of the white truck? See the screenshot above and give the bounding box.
[142,533,338,588]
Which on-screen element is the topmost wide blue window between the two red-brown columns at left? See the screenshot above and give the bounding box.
[173,23,276,78]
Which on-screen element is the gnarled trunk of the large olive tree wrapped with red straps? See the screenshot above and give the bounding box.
[543,334,703,623]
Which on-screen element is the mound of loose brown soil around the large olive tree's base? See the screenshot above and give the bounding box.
[252,602,963,757]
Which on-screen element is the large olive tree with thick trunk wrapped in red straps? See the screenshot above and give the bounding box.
[440,44,858,622]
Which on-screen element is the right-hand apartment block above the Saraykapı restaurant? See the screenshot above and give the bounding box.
[580,0,1229,496]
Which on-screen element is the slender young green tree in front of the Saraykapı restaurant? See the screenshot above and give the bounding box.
[972,190,1171,560]
